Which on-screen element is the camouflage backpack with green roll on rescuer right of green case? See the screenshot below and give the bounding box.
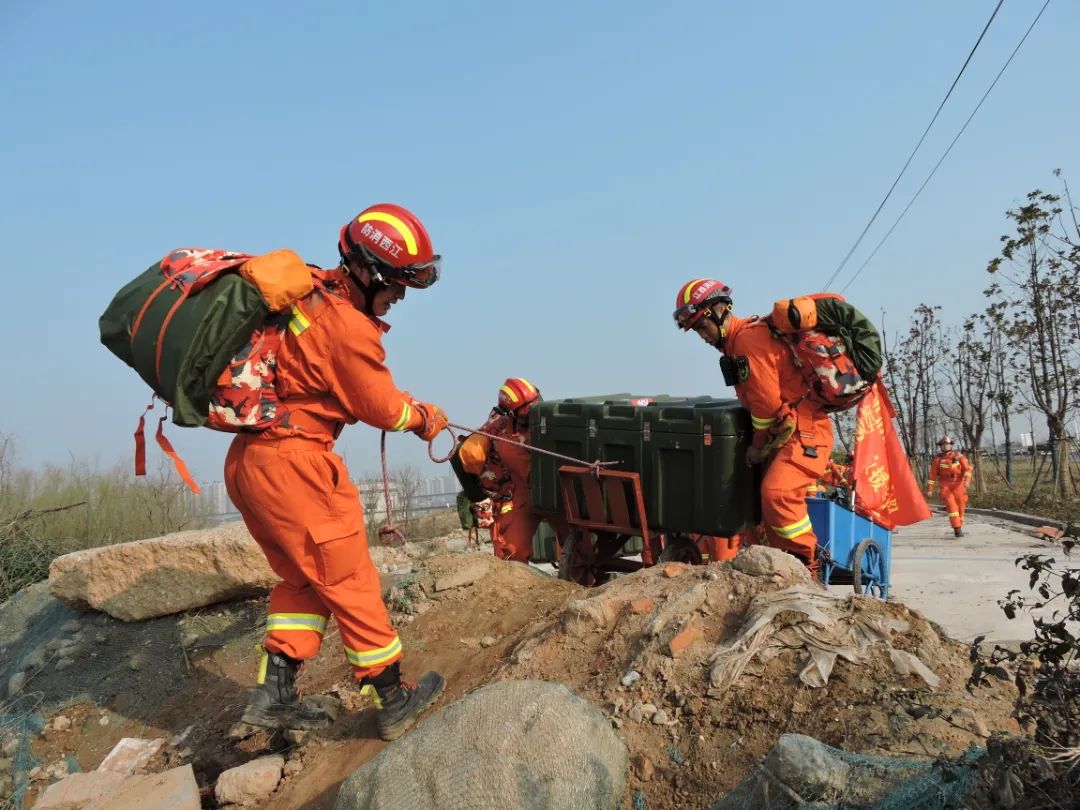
[765,293,881,411]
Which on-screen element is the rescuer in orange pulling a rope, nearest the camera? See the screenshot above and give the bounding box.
[225,204,446,740]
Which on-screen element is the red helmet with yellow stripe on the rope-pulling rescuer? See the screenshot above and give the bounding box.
[338,203,442,288]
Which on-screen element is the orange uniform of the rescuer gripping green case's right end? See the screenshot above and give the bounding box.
[724,314,833,563]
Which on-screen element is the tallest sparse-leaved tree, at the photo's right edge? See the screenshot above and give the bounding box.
[986,182,1080,498]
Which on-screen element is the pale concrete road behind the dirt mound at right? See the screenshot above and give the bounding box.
[889,514,1062,642]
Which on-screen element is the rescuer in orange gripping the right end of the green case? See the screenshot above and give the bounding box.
[674,279,833,568]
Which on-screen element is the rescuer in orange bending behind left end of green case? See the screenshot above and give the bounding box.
[459,377,540,563]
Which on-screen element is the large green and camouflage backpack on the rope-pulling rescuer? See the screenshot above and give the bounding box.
[98,247,322,491]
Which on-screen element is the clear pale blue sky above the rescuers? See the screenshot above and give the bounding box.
[0,0,1080,488]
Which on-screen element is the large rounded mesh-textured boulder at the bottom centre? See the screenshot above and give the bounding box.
[334,680,627,810]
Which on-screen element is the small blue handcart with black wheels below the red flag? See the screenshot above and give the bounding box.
[807,496,892,599]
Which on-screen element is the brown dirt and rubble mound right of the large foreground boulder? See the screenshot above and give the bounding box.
[499,564,1015,808]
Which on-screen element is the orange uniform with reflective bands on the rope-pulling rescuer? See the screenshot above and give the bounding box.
[225,270,423,679]
